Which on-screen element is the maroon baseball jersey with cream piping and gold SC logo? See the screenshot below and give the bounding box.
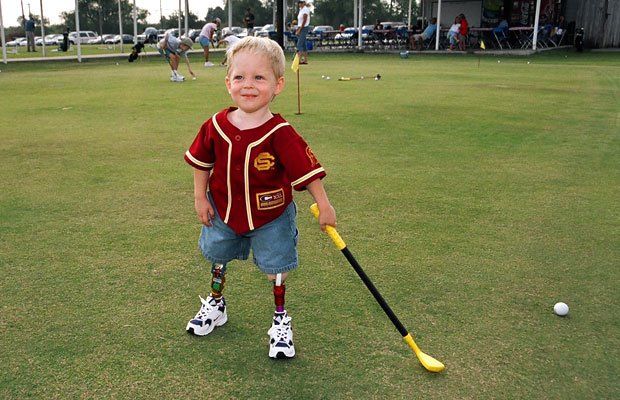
[185,107,326,234]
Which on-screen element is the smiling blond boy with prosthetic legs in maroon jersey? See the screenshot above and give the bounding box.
[185,37,336,358]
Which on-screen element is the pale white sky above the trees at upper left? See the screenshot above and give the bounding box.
[0,0,225,26]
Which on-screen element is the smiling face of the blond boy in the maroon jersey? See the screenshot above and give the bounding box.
[226,50,284,113]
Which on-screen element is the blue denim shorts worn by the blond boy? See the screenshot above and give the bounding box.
[198,202,298,274]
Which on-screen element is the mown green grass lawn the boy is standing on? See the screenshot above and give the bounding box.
[0,52,620,399]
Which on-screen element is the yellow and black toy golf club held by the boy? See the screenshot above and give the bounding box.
[310,203,445,372]
